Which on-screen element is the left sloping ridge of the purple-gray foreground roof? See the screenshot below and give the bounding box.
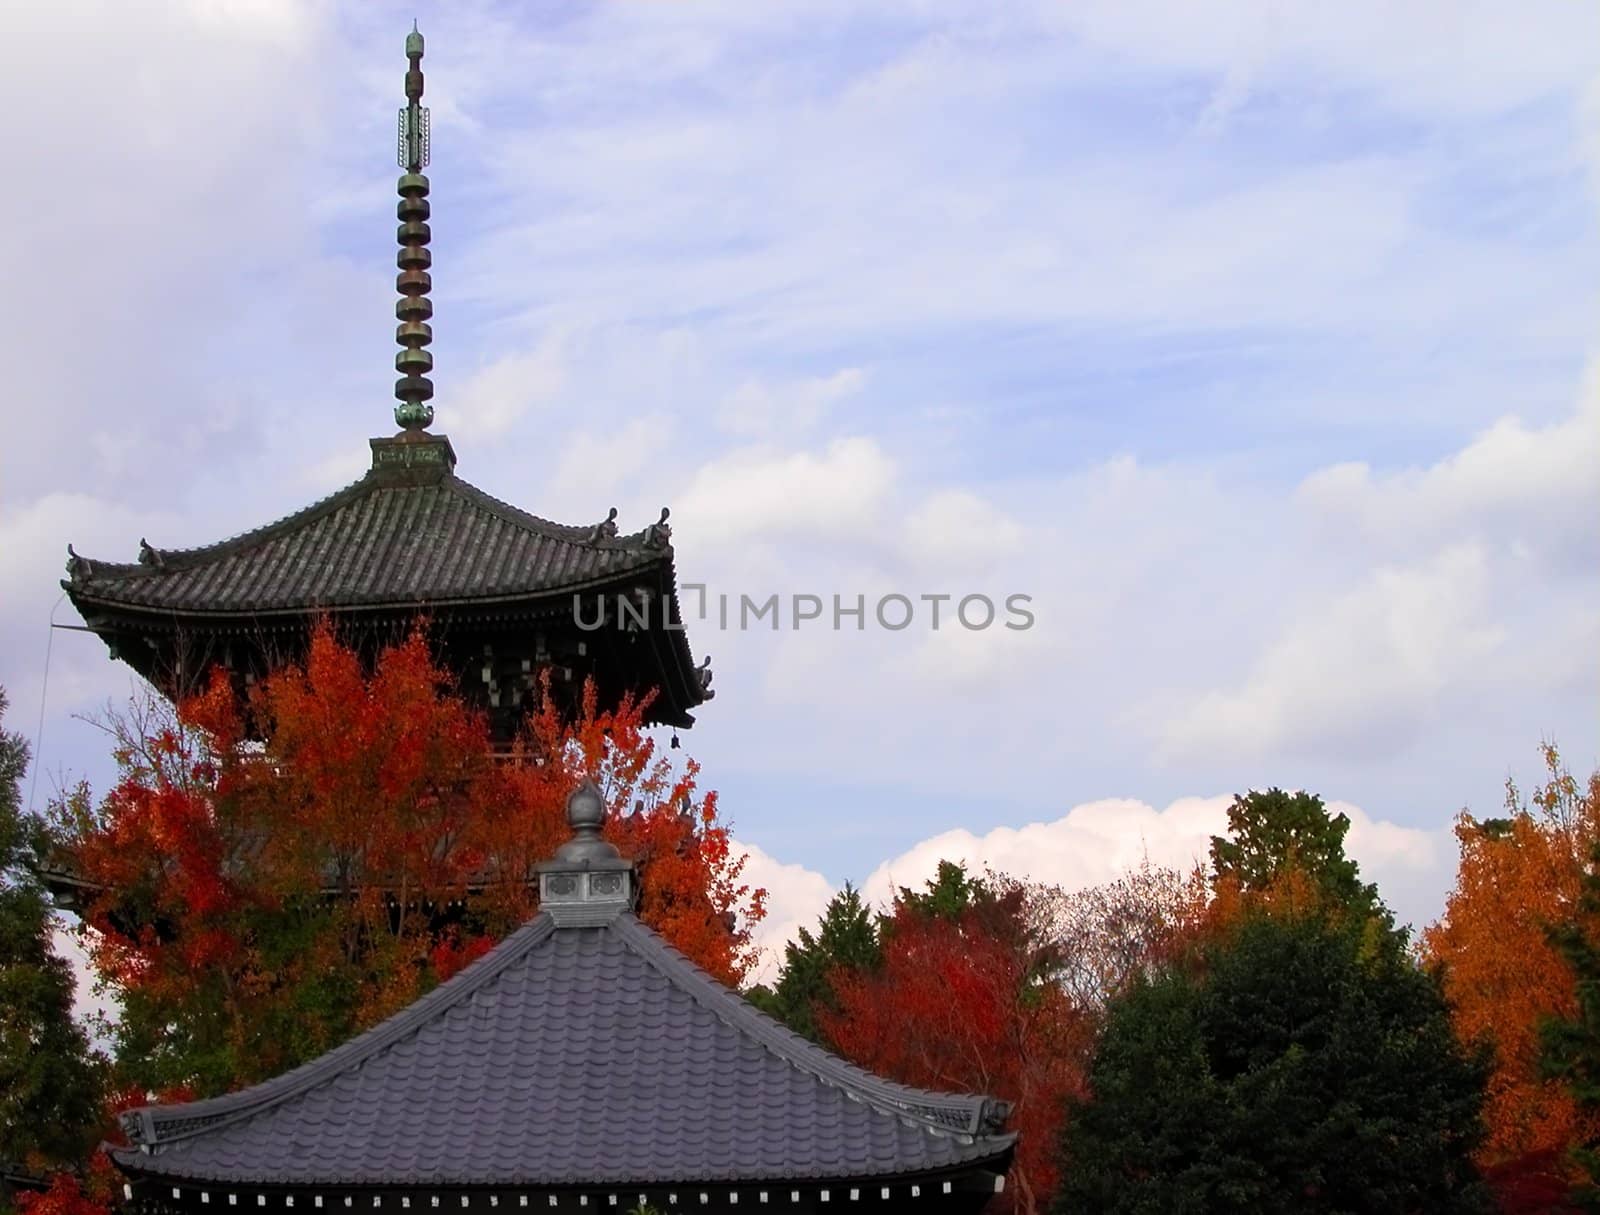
[120,916,555,1149]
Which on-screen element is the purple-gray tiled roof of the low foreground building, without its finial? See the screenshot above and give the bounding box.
[117,912,1014,1186]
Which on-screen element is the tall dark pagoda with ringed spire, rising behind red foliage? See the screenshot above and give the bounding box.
[61,29,712,743]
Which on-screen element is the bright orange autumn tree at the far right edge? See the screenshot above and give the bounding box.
[1421,744,1600,1178]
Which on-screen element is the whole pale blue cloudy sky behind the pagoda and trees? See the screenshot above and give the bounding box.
[0,0,1600,986]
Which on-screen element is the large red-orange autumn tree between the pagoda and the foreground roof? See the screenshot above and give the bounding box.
[56,626,765,1097]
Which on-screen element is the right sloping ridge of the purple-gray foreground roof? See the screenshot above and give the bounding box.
[610,914,1014,1140]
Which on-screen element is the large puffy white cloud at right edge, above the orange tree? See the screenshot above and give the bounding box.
[1160,370,1600,762]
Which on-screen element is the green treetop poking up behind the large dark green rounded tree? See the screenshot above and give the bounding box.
[1211,788,1381,912]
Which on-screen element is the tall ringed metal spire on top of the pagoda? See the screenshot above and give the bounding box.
[395,21,434,431]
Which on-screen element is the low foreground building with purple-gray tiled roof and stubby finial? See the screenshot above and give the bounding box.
[112,783,1016,1215]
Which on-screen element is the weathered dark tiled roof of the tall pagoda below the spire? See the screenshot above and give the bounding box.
[62,471,672,615]
